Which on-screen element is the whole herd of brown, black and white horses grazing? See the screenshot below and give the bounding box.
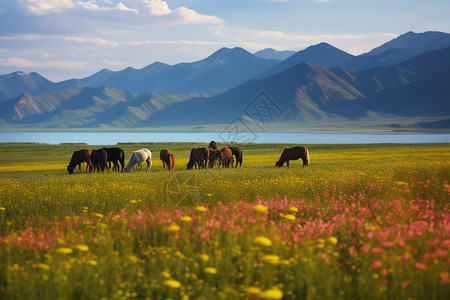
[67,141,309,174]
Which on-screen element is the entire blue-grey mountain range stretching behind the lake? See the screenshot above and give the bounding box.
[0,32,450,129]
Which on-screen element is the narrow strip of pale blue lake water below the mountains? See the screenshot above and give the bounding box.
[0,130,450,145]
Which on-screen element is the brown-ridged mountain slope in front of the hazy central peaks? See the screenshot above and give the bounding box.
[141,64,362,126]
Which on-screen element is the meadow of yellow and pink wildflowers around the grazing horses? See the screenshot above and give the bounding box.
[0,144,450,299]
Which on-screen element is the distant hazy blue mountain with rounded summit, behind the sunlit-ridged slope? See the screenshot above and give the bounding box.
[82,48,277,94]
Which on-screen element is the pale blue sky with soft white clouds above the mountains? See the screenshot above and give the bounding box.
[0,0,450,82]
